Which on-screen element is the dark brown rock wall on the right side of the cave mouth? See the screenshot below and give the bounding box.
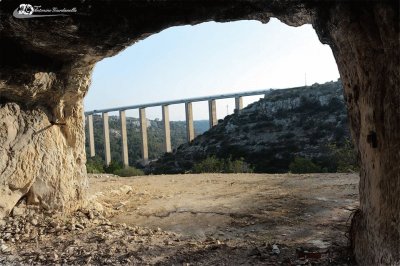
[317,2,400,265]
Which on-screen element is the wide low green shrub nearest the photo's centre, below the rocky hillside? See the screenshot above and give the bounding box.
[192,156,253,173]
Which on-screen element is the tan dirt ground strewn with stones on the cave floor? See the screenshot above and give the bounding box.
[0,174,359,265]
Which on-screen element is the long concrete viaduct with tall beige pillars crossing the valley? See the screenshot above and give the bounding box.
[85,90,270,167]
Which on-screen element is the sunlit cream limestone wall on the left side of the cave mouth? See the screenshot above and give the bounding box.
[0,67,91,217]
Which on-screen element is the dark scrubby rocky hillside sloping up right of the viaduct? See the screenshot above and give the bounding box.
[149,82,350,173]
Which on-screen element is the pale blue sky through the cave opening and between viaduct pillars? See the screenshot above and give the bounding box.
[85,19,339,120]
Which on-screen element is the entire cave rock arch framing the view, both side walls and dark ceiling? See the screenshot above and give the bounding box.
[0,0,400,265]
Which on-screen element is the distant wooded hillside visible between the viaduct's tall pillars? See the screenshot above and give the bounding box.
[85,115,209,165]
